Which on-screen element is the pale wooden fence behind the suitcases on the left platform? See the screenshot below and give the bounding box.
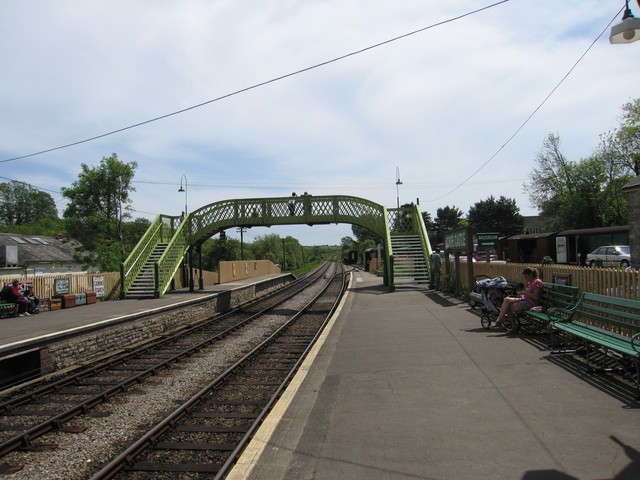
[0,272,120,299]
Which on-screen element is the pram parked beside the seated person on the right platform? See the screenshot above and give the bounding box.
[469,275,520,333]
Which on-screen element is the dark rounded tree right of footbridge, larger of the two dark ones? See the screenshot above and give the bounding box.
[467,195,524,237]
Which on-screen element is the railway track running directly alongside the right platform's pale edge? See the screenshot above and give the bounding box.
[91,264,346,480]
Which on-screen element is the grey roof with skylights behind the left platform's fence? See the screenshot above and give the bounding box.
[0,233,80,265]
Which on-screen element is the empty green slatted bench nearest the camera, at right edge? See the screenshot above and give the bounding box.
[550,292,640,391]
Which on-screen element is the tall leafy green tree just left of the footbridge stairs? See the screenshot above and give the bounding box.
[62,153,137,271]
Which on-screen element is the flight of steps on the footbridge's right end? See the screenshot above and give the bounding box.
[391,235,429,289]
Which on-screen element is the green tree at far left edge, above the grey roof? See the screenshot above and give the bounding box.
[0,180,58,229]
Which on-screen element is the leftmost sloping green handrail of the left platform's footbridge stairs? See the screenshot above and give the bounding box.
[120,215,178,297]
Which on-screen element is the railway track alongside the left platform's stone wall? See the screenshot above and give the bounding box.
[0,263,348,473]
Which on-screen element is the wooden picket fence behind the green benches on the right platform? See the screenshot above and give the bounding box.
[449,261,640,300]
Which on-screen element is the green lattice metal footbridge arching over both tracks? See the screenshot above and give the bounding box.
[121,195,430,297]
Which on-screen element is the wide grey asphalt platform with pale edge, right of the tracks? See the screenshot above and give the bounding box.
[228,272,640,480]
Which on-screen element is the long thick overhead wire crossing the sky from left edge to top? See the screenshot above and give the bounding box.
[0,0,509,163]
